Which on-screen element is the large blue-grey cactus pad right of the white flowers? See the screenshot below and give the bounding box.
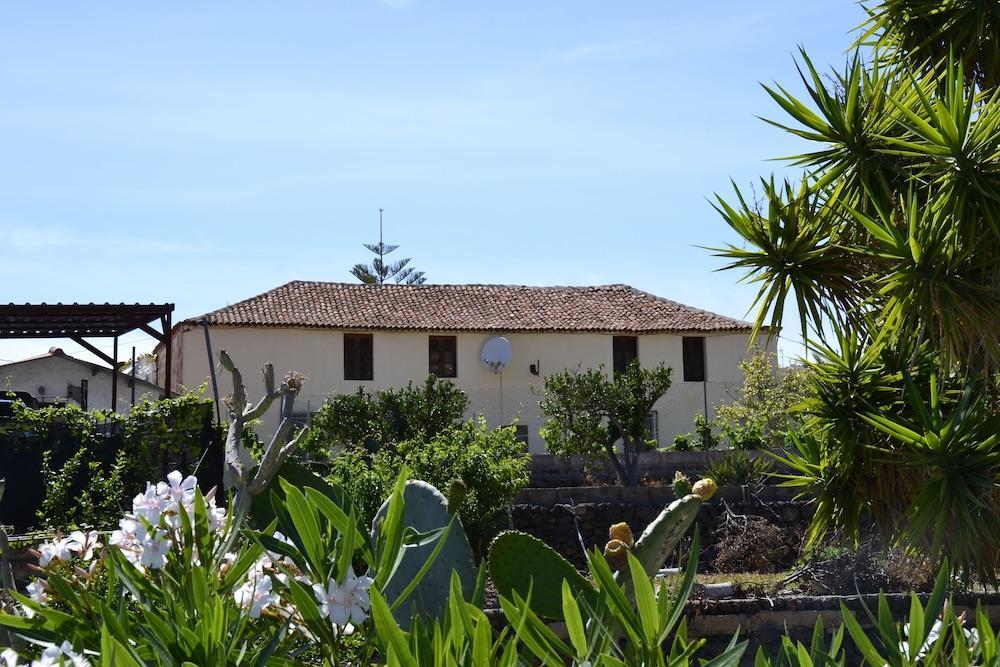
[372,480,476,630]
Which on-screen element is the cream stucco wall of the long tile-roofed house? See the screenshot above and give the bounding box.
[170,327,774,452]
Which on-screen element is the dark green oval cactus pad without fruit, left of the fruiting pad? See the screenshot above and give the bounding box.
[489,530,597,620]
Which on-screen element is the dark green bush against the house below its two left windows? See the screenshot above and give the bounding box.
[300,375,469,464]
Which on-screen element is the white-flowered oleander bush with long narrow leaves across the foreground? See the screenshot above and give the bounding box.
[0,464,1000,667]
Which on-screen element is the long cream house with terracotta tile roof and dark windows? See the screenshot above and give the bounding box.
[160,281,773,452]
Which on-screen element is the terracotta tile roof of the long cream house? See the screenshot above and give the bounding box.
[186,280,750,333]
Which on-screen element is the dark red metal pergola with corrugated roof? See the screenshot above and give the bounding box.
[0,303,174,409]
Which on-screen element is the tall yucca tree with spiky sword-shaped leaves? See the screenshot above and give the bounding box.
[718,0,1000,581]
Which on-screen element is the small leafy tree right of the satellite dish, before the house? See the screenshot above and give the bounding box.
[539,361,671,486]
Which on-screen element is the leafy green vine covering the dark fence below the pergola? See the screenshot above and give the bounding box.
[0,392,221,529]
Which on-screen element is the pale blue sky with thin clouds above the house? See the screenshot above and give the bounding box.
[0,0,863,366]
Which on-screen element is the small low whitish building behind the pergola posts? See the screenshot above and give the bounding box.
[0,347,163,412]
